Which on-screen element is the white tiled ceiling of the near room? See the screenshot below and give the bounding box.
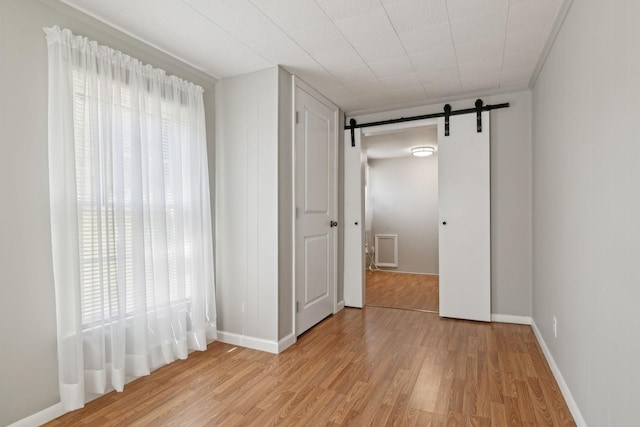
[58,0,563,113]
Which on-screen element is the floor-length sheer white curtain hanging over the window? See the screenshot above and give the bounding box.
[44,27,216,410]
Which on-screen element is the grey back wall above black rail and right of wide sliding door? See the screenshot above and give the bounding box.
[355,91,531,317]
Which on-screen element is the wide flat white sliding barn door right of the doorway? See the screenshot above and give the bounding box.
[438,112,491,322]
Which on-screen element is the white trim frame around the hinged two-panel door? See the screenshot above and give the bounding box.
[291,75,343,342]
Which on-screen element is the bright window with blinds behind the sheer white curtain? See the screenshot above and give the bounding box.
[73,69,191,329]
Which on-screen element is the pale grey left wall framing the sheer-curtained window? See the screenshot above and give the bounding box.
[0,0,215,425]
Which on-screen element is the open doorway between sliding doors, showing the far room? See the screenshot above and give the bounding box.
[362,123,439,313]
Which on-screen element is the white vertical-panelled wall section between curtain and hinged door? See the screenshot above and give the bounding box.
[216,68,278,350]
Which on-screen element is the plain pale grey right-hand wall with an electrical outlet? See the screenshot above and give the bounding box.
[533,0,640,426]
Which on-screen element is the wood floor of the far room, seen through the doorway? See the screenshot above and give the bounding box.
[366,270,439,313]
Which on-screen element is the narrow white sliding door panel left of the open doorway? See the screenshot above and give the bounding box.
[343,129,365,308]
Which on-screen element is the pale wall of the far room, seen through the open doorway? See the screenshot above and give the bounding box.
[367,155,438,274]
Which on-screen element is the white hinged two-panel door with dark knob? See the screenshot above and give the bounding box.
[295,85,337,335]
